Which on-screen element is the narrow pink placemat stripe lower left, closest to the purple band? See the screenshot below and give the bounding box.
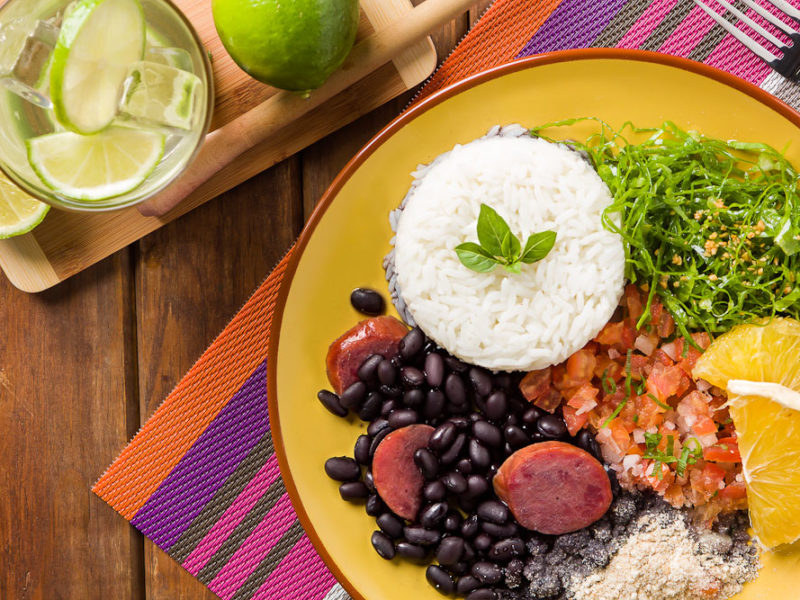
[183,454,280,576]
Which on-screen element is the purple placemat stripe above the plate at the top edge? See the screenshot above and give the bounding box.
[517,0,637,58]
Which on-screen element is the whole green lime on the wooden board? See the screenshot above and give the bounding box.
[211,0,359,92]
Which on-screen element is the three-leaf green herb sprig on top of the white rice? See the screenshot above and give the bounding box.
[455,204,556,273]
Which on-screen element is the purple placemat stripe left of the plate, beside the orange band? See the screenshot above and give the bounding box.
[131,361,269,550]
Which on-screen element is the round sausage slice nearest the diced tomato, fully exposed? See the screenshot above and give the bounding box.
[492,441,612,535]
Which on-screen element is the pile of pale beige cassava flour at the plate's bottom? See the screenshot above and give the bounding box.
[567,506,759,600]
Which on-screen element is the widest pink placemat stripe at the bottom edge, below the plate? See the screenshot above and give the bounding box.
[252,537,338,600]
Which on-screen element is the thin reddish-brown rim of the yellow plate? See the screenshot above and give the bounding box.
[267,48,800,600]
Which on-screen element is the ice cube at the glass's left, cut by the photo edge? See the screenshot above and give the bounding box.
[0,19,58,108]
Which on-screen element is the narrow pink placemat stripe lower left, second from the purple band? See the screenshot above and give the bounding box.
[208,494,297,599]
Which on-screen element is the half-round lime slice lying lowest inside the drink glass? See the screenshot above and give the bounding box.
[26,126,166,200]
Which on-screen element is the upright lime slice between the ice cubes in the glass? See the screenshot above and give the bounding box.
[50,0,145,134]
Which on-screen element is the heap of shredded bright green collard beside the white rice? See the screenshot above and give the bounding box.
[531,118,800,336]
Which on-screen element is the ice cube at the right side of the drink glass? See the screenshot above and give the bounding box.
[120,61,202,130]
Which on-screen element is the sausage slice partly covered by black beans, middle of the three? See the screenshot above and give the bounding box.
[372,425,433,521]
